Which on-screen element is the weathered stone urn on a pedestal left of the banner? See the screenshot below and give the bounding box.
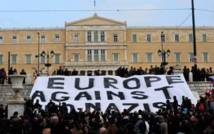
[8,75,25,118]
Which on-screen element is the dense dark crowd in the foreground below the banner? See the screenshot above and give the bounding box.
[0,91,214,134]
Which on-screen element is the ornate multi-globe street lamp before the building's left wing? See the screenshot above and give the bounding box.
[40,50,55,74]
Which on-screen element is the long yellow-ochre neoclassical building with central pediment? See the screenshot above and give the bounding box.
[0,14,214,74]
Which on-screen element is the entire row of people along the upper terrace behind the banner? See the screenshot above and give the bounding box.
[0,66,214,84]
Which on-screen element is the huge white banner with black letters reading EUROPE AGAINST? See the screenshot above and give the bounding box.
[30,75,196,112]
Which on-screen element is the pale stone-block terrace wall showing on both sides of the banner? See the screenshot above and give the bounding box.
[0,82,214,104]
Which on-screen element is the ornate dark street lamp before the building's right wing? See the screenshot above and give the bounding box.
[157,32,170,70]
